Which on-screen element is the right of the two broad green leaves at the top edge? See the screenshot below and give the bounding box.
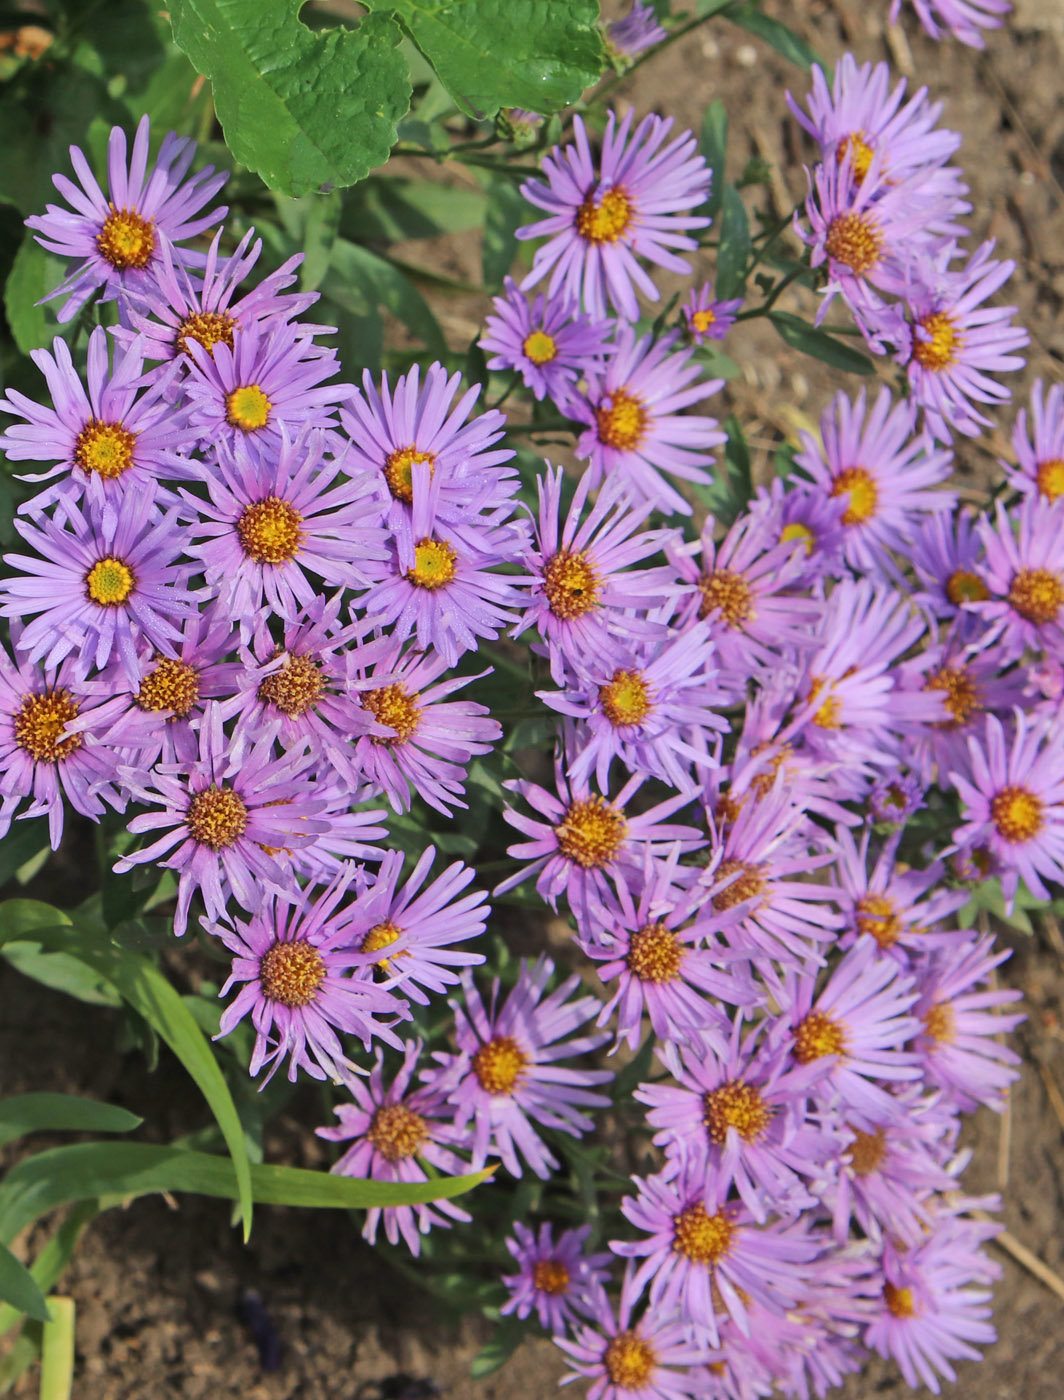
[365,0,606,116]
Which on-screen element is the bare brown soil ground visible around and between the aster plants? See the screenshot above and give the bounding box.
[0,0,1064,1400]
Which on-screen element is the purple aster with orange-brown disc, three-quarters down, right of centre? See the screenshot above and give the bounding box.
[634,1015,834,1221]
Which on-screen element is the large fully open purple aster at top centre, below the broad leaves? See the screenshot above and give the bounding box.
[517,112,710,321]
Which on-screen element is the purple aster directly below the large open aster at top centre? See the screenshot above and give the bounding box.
[566,326,725,515]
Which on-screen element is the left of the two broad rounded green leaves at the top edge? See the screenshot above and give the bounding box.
[169,0,410,195]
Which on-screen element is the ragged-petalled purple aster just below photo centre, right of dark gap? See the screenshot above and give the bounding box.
[494,763,701,921]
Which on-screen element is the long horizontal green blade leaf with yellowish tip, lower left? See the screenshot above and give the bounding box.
[0,1142,494,1240]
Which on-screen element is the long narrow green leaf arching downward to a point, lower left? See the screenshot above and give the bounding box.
[0,899,252,1239]
